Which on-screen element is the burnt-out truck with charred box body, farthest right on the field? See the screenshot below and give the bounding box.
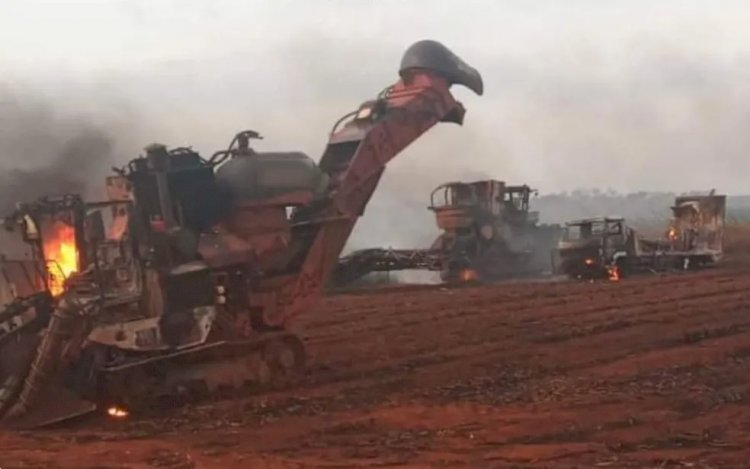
[553,191,726,280]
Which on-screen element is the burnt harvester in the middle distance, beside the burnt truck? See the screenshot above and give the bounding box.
[334,180,562,284]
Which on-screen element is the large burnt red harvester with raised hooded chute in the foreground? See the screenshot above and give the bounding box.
[0,41,483,427]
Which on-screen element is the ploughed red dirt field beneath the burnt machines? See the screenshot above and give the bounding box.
[0,266,750,469]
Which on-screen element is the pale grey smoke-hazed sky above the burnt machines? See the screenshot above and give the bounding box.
[0,0,750,246]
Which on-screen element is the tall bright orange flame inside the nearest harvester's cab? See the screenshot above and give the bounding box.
[43,221,78,296]
